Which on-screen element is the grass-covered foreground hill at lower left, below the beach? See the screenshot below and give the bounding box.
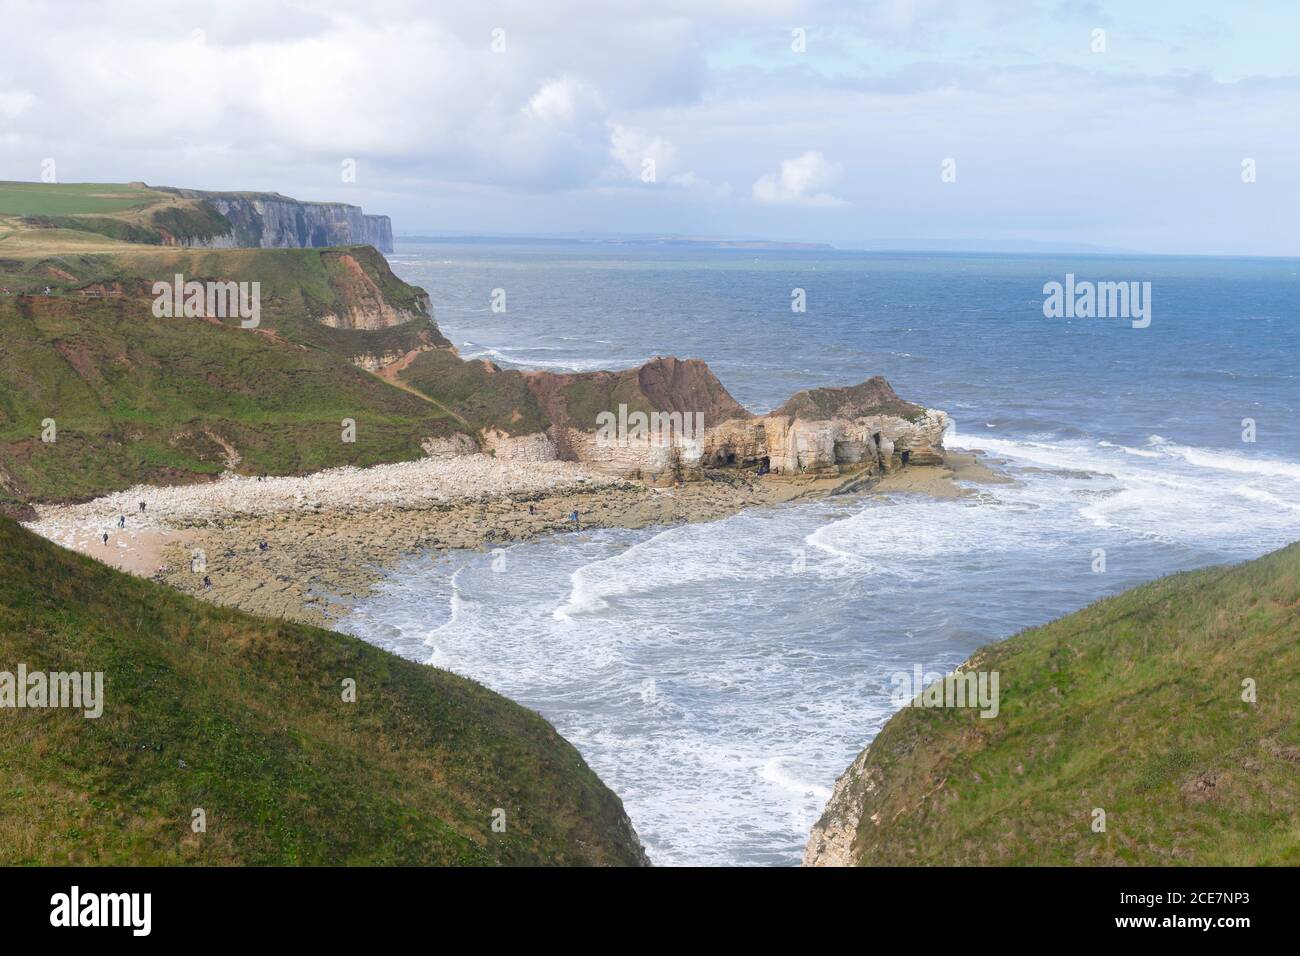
[0,518,644,865]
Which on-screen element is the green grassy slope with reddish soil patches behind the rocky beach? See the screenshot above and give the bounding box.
[0,245,465,510]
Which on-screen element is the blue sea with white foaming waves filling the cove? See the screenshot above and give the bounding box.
[345,243,1300,865]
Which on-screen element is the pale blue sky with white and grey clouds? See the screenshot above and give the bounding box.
[0,0,1300,256]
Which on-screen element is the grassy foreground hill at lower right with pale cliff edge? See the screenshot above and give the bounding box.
[806,544,1300,866]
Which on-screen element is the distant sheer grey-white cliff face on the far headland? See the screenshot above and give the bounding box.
[160,190,393,252]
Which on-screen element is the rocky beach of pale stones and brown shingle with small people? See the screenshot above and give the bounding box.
[27,453,1008,624]
